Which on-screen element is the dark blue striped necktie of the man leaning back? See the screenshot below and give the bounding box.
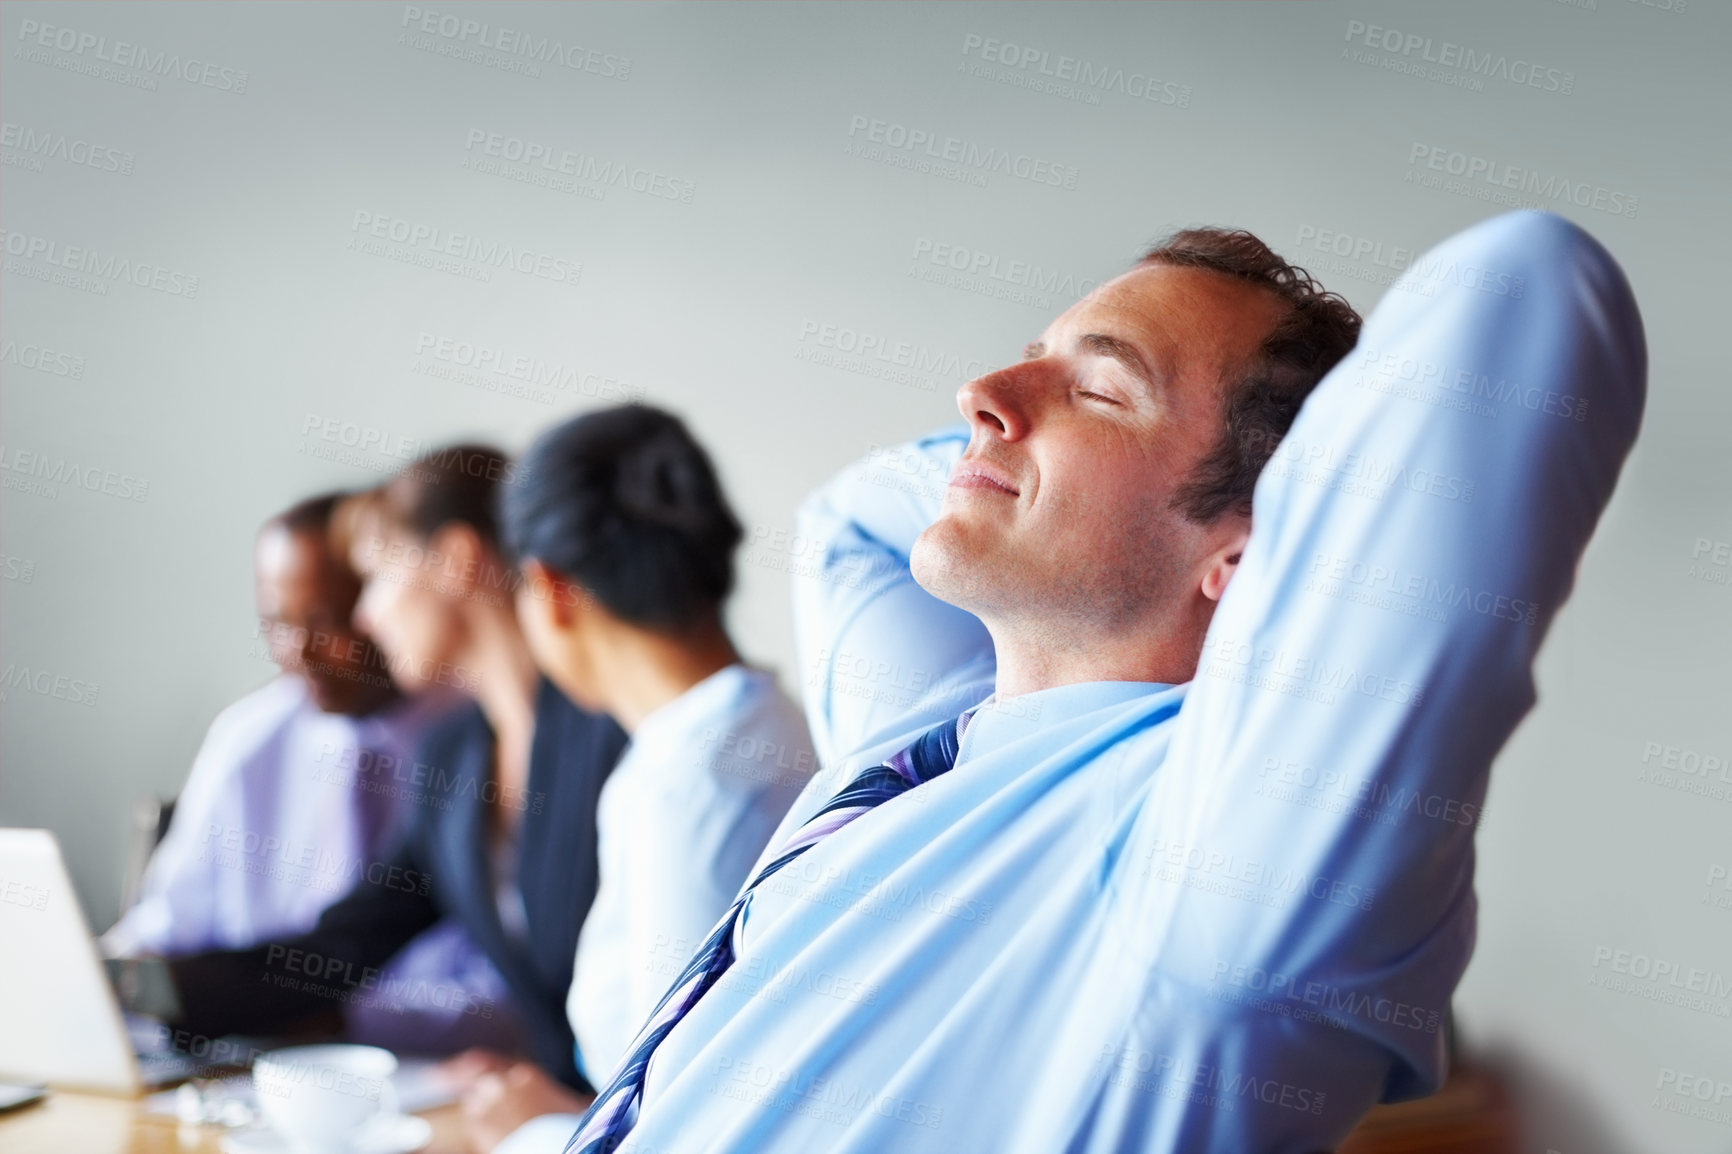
[565,709,973,1154]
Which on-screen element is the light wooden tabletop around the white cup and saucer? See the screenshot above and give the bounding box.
[0,1090,469,1154]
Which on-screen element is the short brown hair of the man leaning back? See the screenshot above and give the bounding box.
[1138,229,1360,523]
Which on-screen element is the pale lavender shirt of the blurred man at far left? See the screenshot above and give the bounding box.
[102,674,513,1050]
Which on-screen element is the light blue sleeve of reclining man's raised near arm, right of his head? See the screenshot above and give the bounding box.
[1115,213,1647,1125]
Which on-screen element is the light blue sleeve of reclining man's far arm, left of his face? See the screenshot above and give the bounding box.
[793,426,996,768]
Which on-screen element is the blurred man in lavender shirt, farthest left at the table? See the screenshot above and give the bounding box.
[102,492,512,1052]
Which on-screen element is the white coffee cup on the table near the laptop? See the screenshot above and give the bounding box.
[253,1045,397,1154]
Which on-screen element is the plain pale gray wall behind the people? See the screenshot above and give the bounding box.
[0,0,1732,1154]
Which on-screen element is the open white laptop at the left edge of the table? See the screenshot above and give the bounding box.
[0,830,251,1093]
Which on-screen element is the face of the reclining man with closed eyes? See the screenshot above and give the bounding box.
[911,259,1278,648]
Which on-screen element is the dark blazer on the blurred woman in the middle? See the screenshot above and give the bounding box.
[170,679,625,1090]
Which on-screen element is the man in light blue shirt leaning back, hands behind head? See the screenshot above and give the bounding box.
[568,213,1645,1154]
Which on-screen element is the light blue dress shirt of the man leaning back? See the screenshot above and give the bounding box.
[602,213,1645,1154]
